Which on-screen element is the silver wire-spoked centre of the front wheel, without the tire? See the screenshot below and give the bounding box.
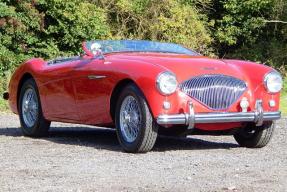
[120,96,142,143]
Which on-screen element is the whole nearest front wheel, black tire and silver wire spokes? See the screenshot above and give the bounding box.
[115,84,158,153]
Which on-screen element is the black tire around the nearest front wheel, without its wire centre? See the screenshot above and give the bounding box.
[115,84,158,153]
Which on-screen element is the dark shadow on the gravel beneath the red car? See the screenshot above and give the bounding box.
[0,127,238,152]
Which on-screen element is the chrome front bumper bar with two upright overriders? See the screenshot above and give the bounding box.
[157,100,281,129]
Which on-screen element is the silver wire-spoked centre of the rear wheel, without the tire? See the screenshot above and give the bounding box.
[22,88,39,127]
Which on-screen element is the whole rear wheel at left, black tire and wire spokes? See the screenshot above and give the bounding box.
[18,79,51,137]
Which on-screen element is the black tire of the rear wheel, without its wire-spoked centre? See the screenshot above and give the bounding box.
[18,79,51,137]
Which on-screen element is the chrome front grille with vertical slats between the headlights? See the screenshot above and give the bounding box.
[180,74,247,110]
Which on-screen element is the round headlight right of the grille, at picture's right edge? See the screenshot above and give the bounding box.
[264,71,283,93]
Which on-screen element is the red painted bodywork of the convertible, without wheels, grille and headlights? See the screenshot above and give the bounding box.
[9,49,280,130]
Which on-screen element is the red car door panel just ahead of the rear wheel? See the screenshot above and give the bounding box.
[41,58,81,122]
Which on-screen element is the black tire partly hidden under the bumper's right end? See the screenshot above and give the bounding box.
[234,122,275,148]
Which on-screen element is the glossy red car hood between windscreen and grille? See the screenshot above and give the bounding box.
[108,54,248,82]
